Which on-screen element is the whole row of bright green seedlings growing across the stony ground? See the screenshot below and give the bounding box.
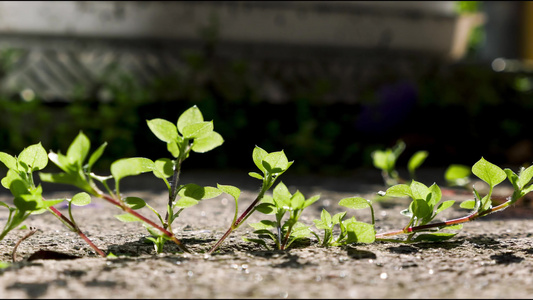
[0,106,533,264]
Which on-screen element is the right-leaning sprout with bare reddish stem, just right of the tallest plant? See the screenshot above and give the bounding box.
[209,146,293,254]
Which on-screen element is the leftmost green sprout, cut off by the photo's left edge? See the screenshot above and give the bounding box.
[0,143,105,257]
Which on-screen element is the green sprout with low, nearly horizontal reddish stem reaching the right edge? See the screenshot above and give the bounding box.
[376,157,533,242]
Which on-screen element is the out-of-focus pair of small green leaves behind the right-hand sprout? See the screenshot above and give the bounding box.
[371,140,429,186]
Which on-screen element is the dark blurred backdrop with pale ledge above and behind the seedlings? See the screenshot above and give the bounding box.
[0,1,533,174]
